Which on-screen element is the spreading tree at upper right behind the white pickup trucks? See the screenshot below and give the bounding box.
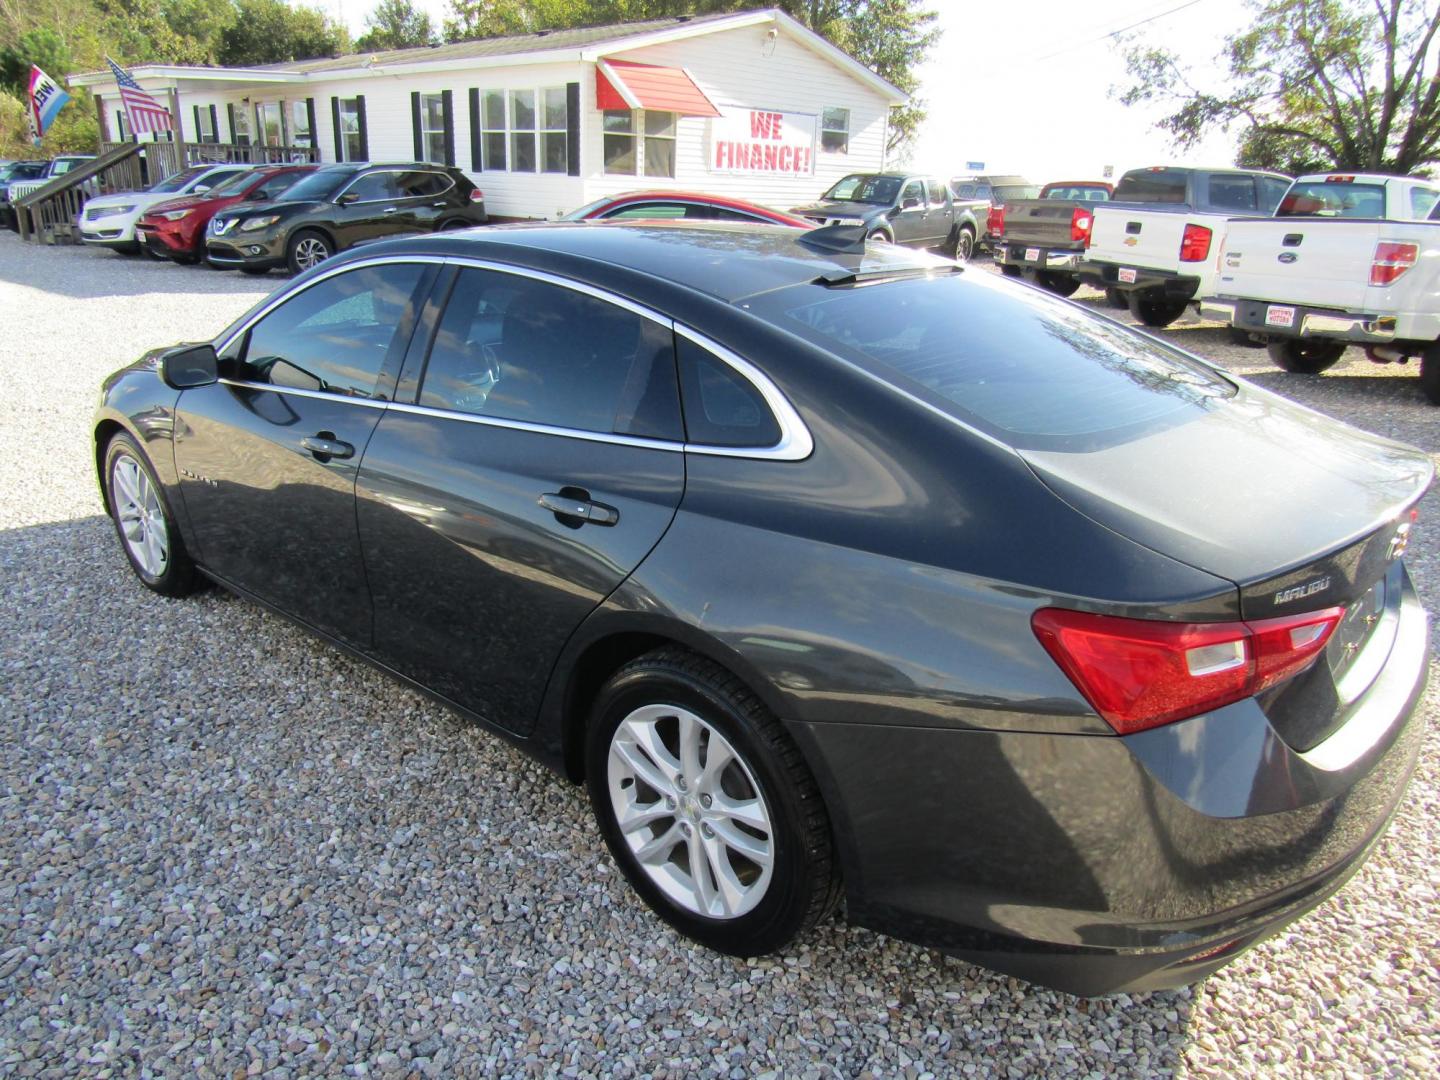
[1120,0,1440,173]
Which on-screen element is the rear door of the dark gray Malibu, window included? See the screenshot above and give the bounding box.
[357,266,685,733]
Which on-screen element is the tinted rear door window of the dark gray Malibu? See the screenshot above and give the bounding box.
[419,268,683,442]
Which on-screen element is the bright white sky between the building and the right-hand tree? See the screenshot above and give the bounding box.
[323,0,1248,183]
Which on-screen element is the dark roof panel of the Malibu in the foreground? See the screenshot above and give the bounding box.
[349,220,955,304]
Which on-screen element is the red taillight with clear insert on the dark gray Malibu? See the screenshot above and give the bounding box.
[1030,608,1345,734]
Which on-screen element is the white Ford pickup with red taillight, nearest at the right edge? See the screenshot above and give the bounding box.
[1200,173,1440,405]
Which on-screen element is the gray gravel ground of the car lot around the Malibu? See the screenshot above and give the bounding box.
[0,233,1440,1077]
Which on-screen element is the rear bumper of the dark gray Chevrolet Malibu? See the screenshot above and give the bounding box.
[796,579,1428,995]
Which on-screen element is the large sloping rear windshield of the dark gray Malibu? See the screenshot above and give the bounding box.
[750,274,1236,451]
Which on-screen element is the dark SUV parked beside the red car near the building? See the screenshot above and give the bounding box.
[204,161,488,274]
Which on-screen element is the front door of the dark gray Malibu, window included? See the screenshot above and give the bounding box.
[174,262,435,648]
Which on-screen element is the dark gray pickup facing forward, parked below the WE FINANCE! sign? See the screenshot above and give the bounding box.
[791,173,979,262]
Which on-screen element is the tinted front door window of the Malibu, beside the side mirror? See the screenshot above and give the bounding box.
[240,264,428,397]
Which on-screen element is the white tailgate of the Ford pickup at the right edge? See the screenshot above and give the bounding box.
[1215,217,1384,311]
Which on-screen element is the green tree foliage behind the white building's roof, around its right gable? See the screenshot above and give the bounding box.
[445,0,940,153]
